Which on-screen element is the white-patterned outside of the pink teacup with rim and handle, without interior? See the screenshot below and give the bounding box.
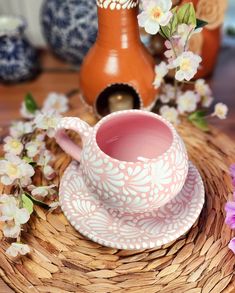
[57,110,188,213]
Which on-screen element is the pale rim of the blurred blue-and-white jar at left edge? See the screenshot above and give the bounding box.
[0,14,27,37]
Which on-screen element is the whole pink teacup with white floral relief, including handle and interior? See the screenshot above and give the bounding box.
[56,110,188,213]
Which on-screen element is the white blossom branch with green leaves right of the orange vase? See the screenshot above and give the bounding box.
[138,0,228,131]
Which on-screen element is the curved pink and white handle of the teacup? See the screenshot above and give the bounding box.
[55,117,92,161]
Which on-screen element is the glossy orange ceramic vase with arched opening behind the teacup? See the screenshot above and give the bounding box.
[80,0,157,116]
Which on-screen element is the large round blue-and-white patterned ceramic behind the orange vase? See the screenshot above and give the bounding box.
[41,0,98,66]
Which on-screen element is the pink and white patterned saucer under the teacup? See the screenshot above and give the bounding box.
[59,161,205,249]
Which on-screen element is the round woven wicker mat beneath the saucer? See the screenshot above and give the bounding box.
[0,108,235,293]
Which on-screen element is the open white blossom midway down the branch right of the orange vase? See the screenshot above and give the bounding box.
[172,51,202,81]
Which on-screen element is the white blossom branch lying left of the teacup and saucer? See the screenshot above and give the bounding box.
[0,93,68,257]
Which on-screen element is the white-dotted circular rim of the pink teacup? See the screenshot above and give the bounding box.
[92,109,179,165]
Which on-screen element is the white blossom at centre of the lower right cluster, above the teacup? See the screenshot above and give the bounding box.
[177,91,199,114]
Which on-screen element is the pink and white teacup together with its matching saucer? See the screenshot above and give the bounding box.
[56,110,204,249]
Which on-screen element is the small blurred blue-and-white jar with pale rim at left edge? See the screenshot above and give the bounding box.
[0,15,40,83]
